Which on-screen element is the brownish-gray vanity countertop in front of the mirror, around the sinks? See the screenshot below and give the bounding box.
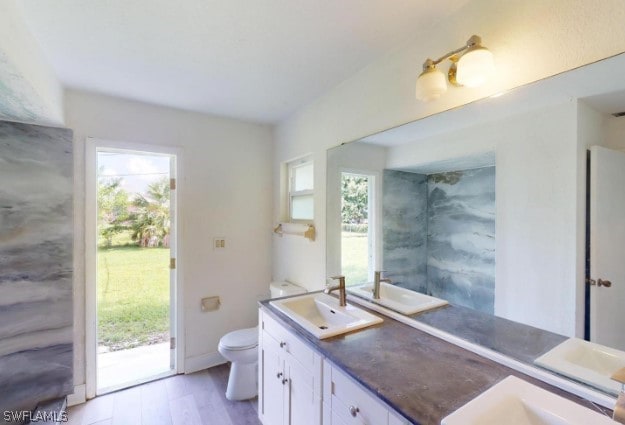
[260,294,610,425]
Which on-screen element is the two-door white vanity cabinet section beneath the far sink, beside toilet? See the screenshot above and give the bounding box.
[258,310,322,425]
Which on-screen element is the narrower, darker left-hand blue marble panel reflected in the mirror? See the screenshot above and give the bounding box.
[382,170,427,292]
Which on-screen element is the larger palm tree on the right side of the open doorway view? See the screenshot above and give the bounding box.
[130,178,171,247]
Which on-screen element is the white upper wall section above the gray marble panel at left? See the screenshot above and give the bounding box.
[0,0,63,126]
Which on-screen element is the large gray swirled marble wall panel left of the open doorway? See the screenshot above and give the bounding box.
[0,121,73,412]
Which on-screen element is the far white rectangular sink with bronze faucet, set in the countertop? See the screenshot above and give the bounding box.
[269,293,383,339]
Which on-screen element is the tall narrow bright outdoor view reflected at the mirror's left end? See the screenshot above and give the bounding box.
[341,172,375,285]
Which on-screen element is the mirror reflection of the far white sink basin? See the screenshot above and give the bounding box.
[347,282,448,314]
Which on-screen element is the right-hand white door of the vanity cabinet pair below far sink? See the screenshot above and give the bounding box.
[285,358,321,425]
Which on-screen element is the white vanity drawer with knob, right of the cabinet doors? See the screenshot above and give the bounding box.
[331,367,388,425]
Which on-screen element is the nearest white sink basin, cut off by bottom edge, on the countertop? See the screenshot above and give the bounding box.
[441,376,615,425]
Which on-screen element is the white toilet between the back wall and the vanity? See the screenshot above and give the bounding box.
[218,282,306,400]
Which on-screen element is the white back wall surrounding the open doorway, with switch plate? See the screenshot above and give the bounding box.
[66,91,272,392]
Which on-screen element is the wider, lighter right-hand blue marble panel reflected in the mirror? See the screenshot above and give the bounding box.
[427,167,495,314]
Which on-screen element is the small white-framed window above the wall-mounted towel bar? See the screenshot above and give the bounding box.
[288,158,315,222]
